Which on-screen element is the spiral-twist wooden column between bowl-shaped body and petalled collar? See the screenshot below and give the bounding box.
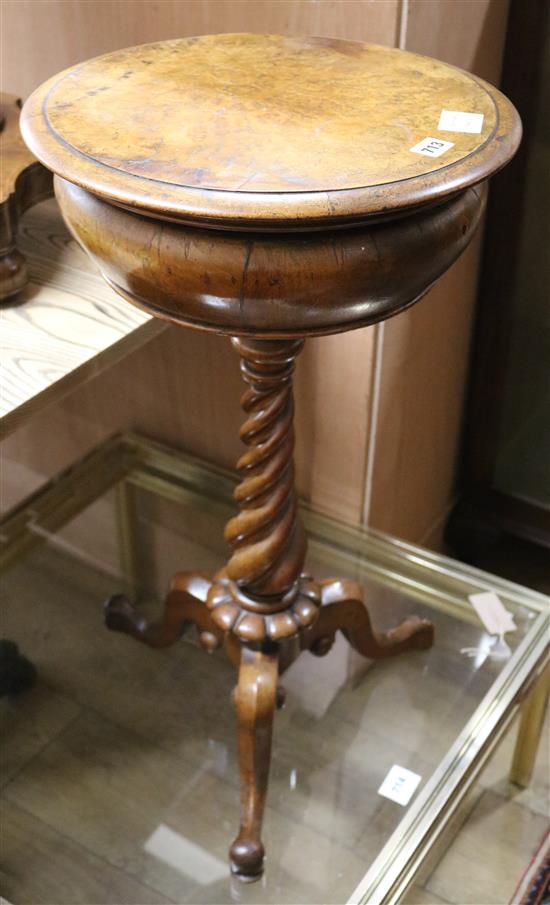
[225,339,306,598]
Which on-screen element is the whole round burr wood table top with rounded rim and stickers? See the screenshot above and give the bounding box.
[22,34,521,229]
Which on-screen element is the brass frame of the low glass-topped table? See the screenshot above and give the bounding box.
[0,434,550,905]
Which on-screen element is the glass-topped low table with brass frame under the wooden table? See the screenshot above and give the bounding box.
[1,435,550,905]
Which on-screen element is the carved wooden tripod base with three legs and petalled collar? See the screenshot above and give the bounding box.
[105,572,433,881]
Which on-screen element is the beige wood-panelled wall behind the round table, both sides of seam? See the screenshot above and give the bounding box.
[2,0,507,543]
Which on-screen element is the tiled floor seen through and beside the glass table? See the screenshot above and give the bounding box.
[0,551,549,905]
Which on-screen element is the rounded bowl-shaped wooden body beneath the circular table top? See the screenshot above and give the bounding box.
[54,176,486,339]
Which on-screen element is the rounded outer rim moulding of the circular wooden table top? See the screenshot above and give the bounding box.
[21,36,521,231]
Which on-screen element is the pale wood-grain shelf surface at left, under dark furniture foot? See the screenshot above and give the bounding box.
[0,201,163,436]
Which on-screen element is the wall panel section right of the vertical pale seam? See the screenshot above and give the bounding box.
[364,0,508,547]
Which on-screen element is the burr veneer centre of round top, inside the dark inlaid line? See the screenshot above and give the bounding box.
[44,35,497,192]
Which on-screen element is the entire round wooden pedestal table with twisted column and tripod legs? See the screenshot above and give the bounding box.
[23,35,520,879]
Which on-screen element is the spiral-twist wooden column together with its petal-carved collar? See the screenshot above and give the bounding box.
[208,338,319,642]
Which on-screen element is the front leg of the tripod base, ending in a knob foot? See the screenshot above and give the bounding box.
[229,647,279,880]
